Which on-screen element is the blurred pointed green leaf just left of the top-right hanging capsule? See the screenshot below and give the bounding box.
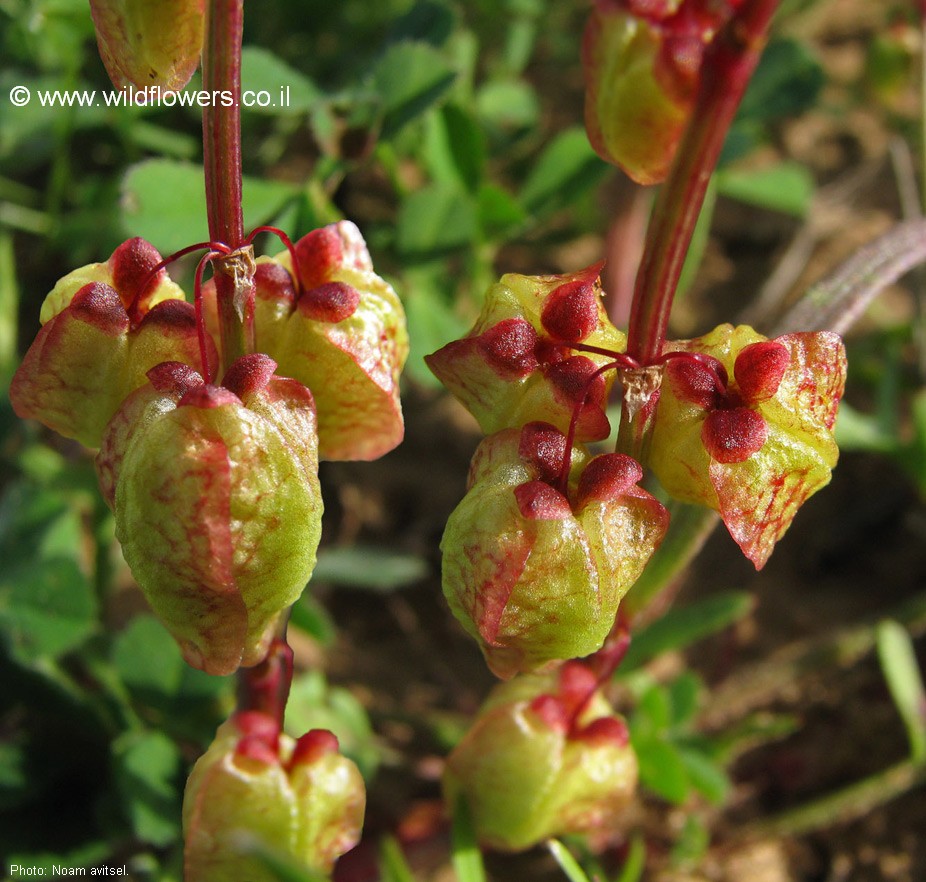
[520,126,608,213]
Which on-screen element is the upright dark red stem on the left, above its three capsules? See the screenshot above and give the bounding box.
[203,0,255,374]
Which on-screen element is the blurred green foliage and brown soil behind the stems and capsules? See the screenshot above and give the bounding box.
[0,0,926,882]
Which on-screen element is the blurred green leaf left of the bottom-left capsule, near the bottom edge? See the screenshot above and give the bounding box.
[112,732,181,846]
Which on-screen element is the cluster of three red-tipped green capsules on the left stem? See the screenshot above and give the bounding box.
[10,222,408,674]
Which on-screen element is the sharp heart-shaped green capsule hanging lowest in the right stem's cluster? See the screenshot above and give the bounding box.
[441,423,668,678]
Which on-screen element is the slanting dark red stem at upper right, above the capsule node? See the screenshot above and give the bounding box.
[627,0,779,365]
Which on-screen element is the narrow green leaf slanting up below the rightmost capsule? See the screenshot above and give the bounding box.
[618,591,753,676]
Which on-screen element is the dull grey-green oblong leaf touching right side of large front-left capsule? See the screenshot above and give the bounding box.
[312,545,428,593]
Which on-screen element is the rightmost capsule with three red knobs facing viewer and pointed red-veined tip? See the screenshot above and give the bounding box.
[649,325,846,569]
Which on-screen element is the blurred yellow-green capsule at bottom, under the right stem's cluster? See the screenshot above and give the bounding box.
[443,662,637,851]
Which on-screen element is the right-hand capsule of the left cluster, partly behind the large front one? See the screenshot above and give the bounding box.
[203,221,408,460]
